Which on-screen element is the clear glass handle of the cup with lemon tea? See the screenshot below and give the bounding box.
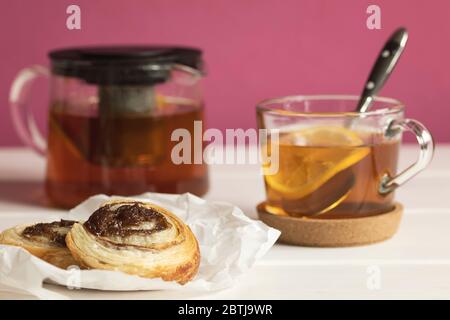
[379,119,434,194]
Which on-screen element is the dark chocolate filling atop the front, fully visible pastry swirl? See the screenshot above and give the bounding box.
[83,202,170,237]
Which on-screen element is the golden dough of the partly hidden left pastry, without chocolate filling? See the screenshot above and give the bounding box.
[0,225,78,269]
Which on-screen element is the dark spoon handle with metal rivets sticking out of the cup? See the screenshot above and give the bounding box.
[356,28,408,112]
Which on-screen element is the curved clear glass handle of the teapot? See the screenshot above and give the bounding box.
[9,65,50,155]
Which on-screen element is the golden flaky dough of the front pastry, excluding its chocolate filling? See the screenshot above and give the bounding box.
[66,201,200,284]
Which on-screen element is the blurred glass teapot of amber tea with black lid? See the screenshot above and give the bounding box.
[10,46,208,207]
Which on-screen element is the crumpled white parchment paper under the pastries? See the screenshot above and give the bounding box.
[0,193,280,299]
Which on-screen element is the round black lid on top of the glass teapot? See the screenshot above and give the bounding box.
[49,46,203,85]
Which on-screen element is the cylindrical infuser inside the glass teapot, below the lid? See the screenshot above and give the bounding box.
[93,85,166,166]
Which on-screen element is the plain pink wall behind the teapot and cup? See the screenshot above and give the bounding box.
[0,0,450,146]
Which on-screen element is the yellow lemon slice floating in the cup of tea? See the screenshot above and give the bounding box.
[263,127,370,199]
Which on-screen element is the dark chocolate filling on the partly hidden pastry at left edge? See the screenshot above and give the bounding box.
[22,219,75,247]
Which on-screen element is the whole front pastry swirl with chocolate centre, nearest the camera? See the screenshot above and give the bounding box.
[66,201,200,284]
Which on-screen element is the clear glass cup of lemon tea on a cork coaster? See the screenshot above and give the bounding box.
[257,95,434,219]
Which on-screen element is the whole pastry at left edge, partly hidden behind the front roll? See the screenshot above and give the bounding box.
[0,220,77,269]
